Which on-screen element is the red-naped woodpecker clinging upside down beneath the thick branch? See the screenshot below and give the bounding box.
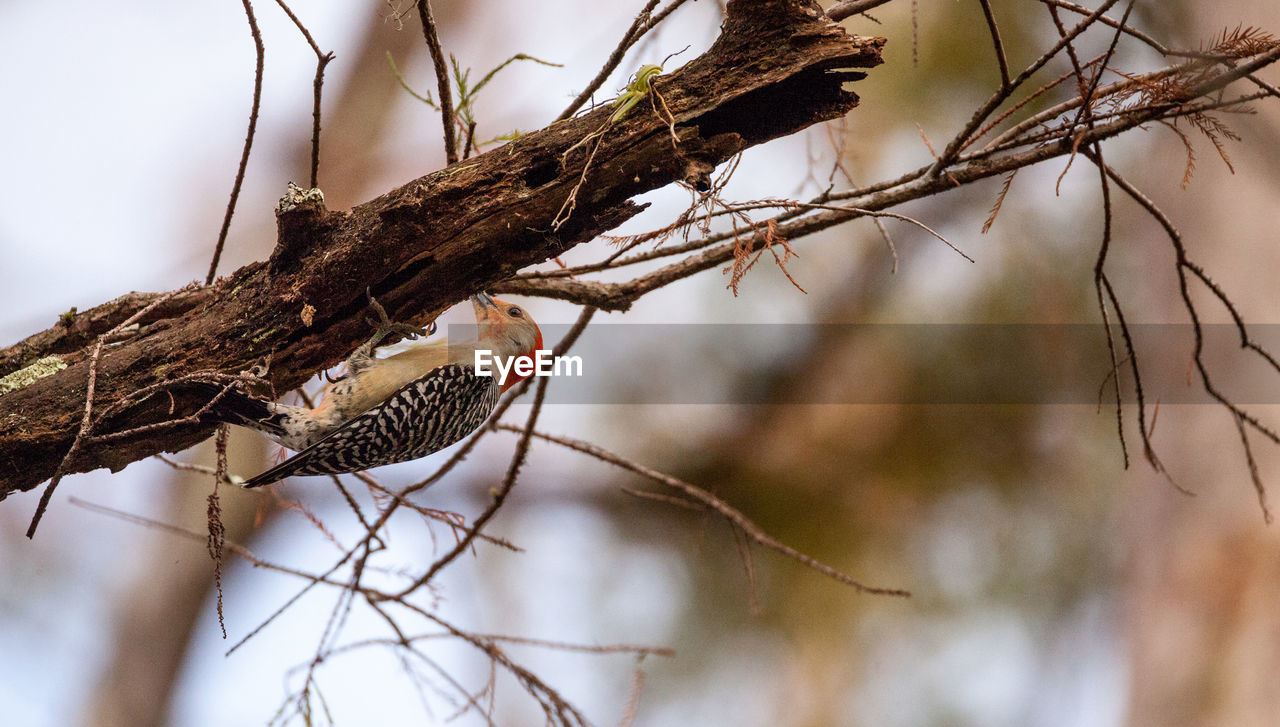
[201,293,543,488]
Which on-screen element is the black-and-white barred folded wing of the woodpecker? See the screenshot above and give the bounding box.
[244,364,498,488]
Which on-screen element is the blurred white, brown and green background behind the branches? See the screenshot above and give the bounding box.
[0,0,1280,727]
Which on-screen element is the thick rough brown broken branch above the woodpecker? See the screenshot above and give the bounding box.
[0,0,884,499]
